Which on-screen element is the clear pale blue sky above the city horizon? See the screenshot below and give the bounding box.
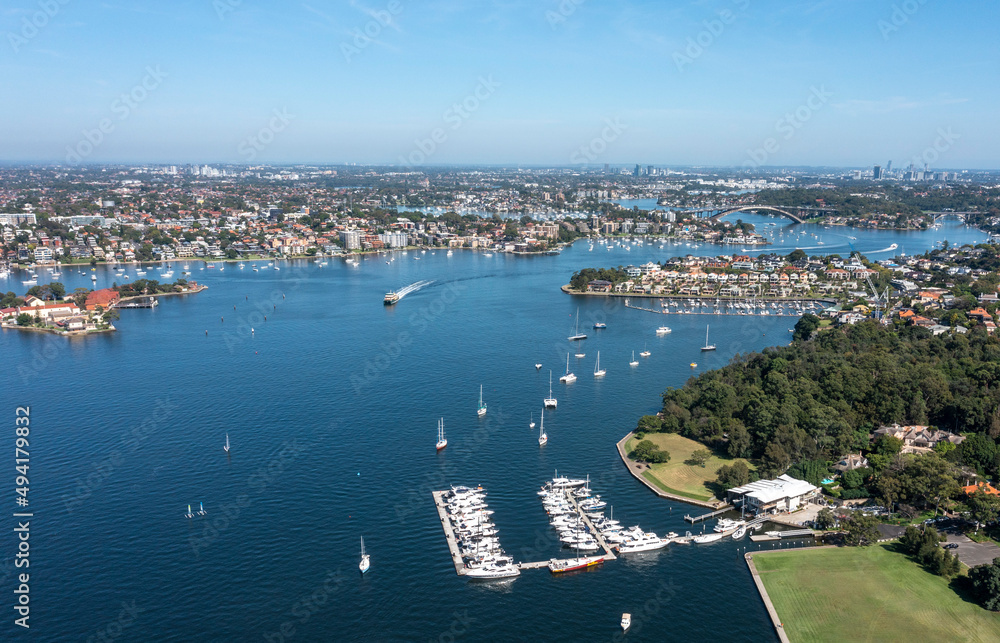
[0,0,1000,168]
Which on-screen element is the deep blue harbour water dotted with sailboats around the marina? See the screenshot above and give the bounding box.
[0,215,986,641]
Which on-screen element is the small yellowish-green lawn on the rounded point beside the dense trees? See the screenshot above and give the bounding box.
[625,433,754,502]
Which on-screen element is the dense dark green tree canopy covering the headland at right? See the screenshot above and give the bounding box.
[661,322,1000,476]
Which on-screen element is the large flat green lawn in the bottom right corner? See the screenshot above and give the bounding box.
[754,545,1000,643]
